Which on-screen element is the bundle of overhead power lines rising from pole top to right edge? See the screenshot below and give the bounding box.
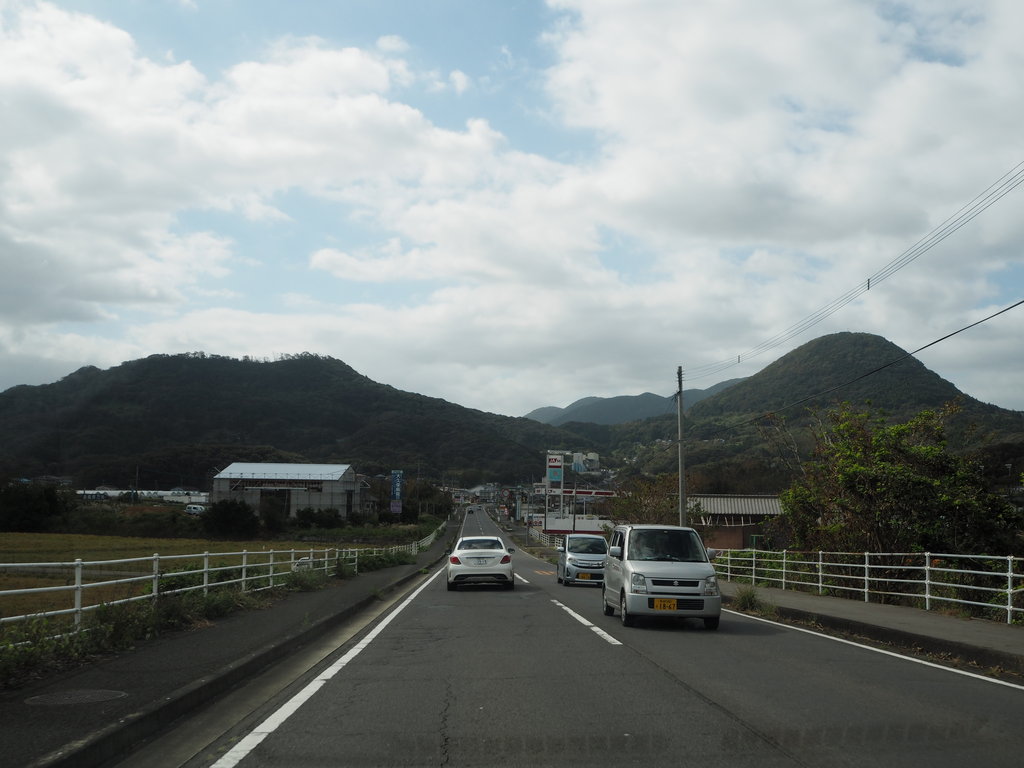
[686,162,1024,379]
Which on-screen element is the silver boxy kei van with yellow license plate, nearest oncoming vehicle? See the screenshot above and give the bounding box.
[601,525,722,630]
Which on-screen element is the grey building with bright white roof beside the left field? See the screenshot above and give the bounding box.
[210,462,359,517]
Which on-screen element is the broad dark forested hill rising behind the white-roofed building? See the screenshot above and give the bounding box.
[0,353,591,488]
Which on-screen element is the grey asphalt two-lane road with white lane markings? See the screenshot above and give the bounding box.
[138,514,1024,768]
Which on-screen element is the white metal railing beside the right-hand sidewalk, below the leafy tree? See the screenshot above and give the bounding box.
[715,549,1024,624]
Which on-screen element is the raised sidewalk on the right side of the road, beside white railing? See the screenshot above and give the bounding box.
[506,523,1024,677]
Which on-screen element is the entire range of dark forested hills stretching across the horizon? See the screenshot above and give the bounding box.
[0,333,1024,493]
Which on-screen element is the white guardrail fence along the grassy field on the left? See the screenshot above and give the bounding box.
[0,524,444,626]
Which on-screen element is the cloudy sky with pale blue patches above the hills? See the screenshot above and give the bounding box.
[0,0,1024,416]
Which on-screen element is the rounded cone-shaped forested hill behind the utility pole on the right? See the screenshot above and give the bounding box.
[564,333,1024,493]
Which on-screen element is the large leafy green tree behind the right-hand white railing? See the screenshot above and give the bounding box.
[773,403,1024,555]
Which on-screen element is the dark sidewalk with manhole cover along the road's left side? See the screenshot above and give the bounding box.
[0,519,460,768]
